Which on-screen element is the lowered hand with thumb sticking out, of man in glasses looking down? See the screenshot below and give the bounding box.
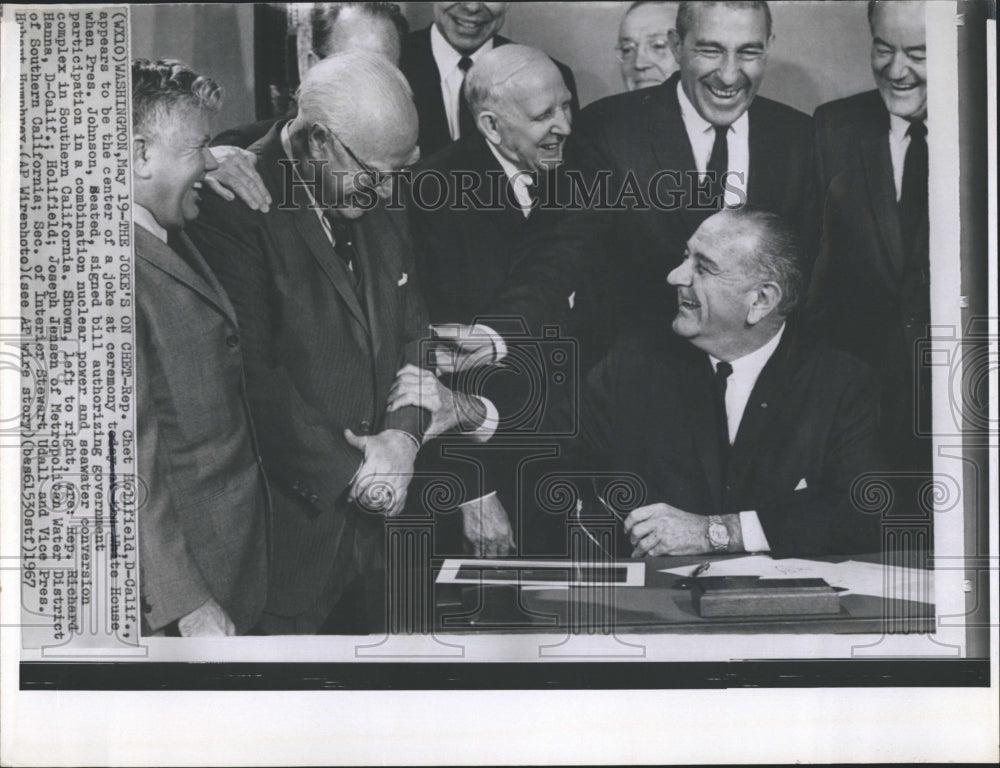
[344,429,418,517]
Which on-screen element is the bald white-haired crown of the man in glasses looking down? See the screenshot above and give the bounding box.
[291,51,417,164]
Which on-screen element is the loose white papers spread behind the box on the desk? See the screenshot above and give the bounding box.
[661,555,934,603]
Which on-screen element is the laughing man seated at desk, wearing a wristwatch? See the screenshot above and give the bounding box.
[580,208,881,557]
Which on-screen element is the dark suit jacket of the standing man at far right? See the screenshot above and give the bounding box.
[807,91,930,468]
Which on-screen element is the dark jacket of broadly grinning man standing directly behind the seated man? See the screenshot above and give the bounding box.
[525,73,817,368]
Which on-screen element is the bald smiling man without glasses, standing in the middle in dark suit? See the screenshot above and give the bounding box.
[398,44,574,556]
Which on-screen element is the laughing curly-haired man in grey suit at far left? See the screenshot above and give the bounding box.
[132,59,267,636]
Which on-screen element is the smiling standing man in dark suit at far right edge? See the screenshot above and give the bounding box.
[808,2,931,472]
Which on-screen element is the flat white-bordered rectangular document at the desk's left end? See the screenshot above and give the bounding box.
[437,558,646,588]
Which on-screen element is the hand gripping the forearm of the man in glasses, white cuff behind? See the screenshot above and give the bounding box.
[386,365,486,442]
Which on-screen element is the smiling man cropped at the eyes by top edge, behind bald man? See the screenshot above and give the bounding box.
[400,2,580,157]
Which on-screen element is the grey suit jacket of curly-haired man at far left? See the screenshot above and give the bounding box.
[135,226,267,633]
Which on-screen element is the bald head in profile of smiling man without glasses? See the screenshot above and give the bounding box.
[465,44,571,171]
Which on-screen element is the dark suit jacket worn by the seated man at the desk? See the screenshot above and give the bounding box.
[580,328,881,557]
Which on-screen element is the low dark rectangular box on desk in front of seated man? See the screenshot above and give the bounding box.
[691,576,840,618]
